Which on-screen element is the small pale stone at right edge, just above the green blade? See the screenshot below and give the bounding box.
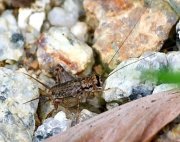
[167,51,180,72]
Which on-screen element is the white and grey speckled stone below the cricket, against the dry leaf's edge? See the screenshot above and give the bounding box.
[33,111,71,142]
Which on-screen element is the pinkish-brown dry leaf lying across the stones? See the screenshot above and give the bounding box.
[46,90,180,142]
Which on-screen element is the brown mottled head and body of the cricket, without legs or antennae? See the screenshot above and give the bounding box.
[50,75,103,99]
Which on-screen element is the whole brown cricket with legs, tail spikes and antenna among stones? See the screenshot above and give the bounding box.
[26,53,155,122]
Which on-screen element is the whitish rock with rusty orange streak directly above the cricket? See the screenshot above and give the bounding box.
[37,27,94,75]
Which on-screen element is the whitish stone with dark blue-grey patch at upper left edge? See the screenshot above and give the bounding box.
[0,10,24,61]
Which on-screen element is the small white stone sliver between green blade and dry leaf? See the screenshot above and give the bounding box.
[153,84,179,94]
